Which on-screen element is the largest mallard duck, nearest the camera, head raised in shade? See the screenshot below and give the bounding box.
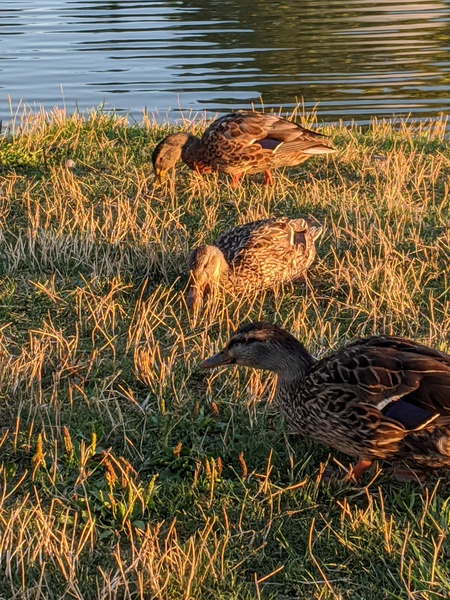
[200,322,450,480]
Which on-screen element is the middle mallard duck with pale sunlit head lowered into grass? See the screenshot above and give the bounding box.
[186,217,322,309]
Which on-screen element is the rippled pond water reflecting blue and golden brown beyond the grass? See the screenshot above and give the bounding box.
[0,0,450,123]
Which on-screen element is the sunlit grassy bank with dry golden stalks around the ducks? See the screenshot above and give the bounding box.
[0,112,450,600]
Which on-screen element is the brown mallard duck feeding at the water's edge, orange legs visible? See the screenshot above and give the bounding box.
[152,111,337,185]
